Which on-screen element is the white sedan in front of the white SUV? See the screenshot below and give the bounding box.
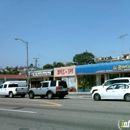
[92,83,130,102]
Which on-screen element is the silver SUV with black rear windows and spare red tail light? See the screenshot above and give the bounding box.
[28,80,68,99]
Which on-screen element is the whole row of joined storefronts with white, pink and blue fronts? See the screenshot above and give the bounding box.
[29,61,130,92]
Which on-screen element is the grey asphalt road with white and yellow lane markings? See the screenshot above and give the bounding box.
[0,95,130,130]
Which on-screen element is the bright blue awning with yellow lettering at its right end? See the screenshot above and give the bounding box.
[76,61,130,74]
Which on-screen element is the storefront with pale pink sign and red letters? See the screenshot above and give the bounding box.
[54,66,77,92]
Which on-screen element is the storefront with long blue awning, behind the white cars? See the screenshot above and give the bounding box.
[76,61,130,85]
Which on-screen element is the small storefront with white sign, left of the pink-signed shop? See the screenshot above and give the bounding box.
[29,69,54,88]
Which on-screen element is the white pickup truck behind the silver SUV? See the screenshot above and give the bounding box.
[0,81,28,98]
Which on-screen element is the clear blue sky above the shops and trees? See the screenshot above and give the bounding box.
[0,0,130,68]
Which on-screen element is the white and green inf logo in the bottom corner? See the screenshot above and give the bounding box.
[118,119,130,130]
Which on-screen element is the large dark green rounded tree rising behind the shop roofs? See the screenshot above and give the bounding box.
[73,51,95,65]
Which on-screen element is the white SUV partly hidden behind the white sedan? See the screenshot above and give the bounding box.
[90,77,130,94]
